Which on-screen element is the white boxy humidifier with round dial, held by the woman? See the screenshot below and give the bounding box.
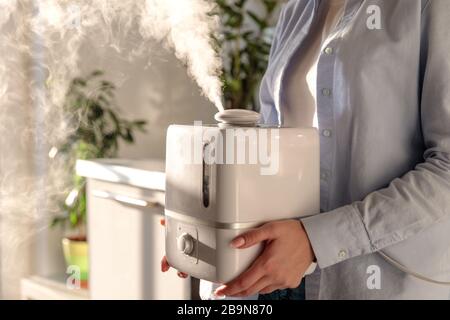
[165,110,320,283]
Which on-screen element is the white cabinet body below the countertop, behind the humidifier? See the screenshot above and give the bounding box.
[87,178,191,299]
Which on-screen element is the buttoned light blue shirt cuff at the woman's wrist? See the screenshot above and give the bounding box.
[301,205,373,269]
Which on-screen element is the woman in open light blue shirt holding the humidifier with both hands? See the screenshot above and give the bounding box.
[163,0,450,299]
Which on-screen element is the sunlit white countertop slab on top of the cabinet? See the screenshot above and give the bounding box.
[76,159,165,191]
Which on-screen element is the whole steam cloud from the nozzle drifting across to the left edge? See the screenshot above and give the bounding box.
[0,0,223,296]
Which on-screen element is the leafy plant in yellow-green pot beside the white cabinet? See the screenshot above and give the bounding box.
[49,71,146,286]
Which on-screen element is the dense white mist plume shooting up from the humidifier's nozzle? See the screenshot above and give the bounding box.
[141,0,223,111]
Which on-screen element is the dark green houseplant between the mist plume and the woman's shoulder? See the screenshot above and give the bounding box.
[213,0,283,111]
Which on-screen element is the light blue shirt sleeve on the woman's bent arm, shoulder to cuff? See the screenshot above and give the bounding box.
[302,0,450,268]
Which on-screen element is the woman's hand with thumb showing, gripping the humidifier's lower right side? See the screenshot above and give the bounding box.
[215,220,314,297]
